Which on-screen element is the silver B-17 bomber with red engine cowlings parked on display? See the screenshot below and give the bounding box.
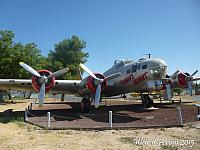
[0,57,200,112]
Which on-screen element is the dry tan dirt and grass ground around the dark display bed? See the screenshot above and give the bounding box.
[0,96,200,150]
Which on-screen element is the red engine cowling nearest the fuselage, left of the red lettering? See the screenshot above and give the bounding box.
[86,73,108,93]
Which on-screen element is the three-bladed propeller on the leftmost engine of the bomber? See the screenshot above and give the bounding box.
[19,62,69,106]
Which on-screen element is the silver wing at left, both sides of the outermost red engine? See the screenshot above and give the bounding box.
[0,79,81,95]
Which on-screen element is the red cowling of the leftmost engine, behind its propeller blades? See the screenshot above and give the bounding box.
[32,70,55,92]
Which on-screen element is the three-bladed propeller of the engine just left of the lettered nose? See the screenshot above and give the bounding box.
[80,64,121,108]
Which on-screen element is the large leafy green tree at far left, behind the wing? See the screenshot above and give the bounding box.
[0,30,46,99]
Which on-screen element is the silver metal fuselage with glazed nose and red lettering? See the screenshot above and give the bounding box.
[103,58,167,96]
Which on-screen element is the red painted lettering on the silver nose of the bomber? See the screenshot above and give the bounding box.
[120,72,148,85]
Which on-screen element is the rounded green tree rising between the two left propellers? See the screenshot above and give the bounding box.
[47,36,89,79]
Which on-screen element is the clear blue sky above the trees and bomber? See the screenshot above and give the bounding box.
[0,0,200,75]
